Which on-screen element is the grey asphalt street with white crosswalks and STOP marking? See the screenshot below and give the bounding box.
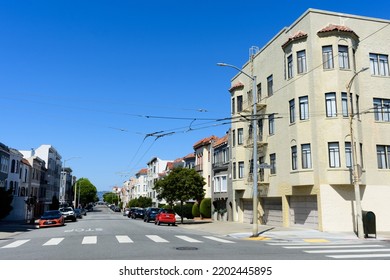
[0,206,390,260]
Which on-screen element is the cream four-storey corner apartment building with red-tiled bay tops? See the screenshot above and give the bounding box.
[230,9,390,231]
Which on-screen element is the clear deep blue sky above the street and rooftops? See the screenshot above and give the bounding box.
[0,0,390,190]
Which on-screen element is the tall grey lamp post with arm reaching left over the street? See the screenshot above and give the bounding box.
[217,63,259,237]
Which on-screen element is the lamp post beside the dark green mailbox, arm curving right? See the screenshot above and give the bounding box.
[347,67,368,238]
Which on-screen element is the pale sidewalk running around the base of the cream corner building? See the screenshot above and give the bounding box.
[177,220,390,242]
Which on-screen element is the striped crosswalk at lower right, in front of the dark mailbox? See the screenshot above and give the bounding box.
[267,241,390,260]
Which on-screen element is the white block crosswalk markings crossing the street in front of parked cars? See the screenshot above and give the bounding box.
[0,235,235,249]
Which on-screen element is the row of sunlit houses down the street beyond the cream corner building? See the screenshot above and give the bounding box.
[114,133,231,219]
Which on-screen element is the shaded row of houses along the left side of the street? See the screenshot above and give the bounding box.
[0,143,76,220]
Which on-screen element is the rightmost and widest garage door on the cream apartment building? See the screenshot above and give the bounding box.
[290,195,318,229]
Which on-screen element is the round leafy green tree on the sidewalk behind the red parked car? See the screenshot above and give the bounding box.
[153,167,206,223]
